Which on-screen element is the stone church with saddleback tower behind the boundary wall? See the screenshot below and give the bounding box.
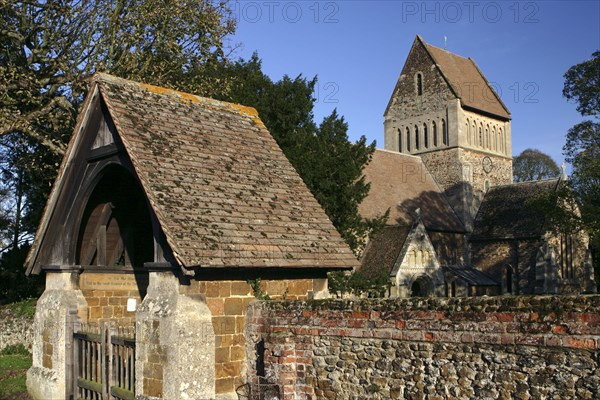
[359,36,596,297]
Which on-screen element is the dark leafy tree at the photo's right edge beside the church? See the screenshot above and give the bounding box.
[563,51,600,288]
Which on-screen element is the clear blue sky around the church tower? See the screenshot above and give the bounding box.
[231,0,600,164]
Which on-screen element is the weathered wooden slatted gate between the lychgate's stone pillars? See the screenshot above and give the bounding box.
[73,324,135,400]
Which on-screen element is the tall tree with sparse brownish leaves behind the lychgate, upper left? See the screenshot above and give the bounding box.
[0,0,235,300]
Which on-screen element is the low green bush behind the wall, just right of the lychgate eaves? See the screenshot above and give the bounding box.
[327,271,391,298]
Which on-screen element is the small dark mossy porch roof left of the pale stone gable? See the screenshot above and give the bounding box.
[360,225,411,278]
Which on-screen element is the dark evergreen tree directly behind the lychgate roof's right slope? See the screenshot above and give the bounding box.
[222,54,385,252]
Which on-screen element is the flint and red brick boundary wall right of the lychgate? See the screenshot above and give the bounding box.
[246,296,600,399]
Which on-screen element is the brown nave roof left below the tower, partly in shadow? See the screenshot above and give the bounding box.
[359,149,464,232]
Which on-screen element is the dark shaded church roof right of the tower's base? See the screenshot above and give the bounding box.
[471,179,559,239]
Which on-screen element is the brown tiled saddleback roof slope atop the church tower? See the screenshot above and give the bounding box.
[417,36,510,119]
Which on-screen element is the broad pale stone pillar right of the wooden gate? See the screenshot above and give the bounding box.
[135,271,215,400]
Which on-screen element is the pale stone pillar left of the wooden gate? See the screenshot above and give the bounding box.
[27,272,87,400]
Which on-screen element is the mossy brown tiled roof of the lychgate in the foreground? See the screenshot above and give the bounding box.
[30,74,358,268]
